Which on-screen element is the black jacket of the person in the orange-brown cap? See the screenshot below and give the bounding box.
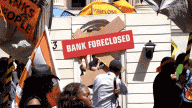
[153,72,182,108]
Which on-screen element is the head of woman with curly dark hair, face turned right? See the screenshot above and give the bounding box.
[58,83,92,108]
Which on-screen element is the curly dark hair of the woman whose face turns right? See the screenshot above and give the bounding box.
[58,83,85,108]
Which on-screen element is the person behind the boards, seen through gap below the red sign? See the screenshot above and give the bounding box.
[89,55,105,71]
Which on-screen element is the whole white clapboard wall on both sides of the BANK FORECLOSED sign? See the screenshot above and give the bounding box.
[50,14,171,108]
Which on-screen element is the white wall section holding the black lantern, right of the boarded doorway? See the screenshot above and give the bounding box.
[126,14,171,108]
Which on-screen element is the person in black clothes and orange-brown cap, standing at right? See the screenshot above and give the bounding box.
[153,57,182,108]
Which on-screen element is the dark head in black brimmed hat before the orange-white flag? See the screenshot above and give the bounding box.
[20,65,59,108]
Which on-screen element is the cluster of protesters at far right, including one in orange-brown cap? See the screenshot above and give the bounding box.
[153,53,192,108]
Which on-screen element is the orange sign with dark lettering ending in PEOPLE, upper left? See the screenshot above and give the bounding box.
[0,0,40,41]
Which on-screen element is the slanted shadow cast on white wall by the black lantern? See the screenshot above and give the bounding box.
[133,47,151,81]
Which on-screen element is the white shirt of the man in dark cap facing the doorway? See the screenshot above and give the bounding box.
[93,72,128,108]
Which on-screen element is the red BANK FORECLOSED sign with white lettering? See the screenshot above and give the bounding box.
[62,30,134,59]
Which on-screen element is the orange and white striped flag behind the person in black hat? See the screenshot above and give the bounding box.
[12,26,60,108]
